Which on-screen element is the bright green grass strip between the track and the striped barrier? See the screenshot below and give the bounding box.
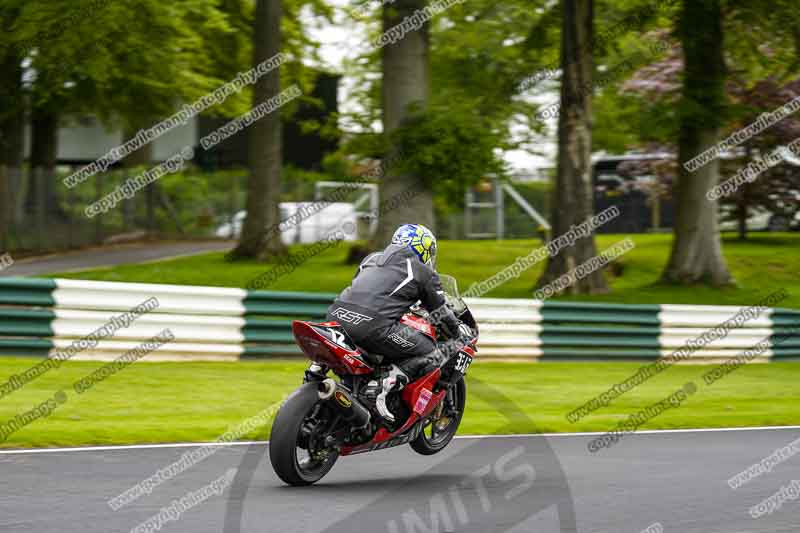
[0,358,800,447]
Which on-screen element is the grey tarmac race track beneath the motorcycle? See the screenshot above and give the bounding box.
[0,429,800,533]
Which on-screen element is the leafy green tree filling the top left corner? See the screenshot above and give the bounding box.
[3,0,238,237]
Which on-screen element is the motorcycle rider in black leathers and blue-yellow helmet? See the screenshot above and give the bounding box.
[327,224,471,422]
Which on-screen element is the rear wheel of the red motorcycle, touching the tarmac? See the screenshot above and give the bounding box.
[269,383,339,486]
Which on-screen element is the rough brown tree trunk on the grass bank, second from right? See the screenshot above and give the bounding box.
[538,0,608,294]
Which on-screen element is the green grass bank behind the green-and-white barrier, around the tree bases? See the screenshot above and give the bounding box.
[54,233,800,308]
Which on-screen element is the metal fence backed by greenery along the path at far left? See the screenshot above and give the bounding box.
[0,167,252,252]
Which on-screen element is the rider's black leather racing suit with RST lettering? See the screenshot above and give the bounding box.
[327,245,459,376]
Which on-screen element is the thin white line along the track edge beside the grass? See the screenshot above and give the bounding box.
[0,426,800,455]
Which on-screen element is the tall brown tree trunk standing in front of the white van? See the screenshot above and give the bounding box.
[229,0,287,259]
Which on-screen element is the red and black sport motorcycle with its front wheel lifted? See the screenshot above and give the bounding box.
[269,276,478,486]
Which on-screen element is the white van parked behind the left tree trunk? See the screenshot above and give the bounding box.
[214,202,358,245]
